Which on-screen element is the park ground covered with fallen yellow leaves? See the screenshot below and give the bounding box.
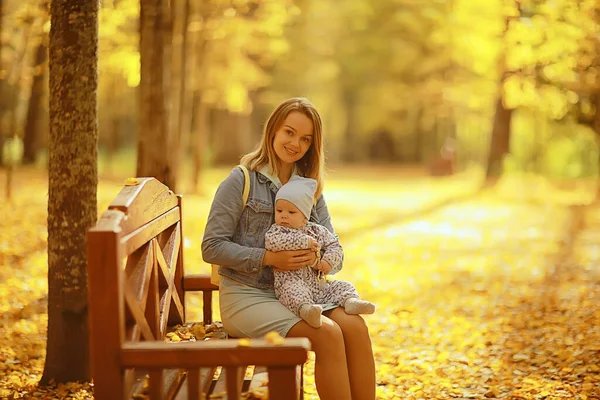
[0,169,600,400]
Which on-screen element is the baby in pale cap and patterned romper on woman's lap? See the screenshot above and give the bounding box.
[265,176,375,328]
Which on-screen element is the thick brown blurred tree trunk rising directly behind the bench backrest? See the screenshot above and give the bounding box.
[137,0,176,190]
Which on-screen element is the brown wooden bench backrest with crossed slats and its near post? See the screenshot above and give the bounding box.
[87,178,185,399]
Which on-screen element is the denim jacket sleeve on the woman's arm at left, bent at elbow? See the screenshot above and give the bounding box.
[202,168,265,272]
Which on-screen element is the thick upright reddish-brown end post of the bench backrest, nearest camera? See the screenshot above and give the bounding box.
[87,227,125,400]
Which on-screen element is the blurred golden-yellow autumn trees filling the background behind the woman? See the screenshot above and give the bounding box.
[0,0,600,191]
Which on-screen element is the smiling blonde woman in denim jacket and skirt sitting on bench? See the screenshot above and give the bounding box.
[202,98,375,400]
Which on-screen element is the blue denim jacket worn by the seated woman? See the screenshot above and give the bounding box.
[202,167,343,289]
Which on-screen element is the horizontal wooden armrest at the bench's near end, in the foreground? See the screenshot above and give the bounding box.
[121,338,310,369]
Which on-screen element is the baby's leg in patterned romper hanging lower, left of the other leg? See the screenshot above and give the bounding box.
[275,272,323,328]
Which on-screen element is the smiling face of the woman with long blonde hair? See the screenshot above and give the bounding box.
[273,111,313,164]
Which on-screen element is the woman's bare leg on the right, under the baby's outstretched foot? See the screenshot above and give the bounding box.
[323,307,376,400]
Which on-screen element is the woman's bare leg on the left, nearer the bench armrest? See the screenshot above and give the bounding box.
[287,318,353,400]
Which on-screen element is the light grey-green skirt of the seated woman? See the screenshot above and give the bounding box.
[219,276,337,338]
